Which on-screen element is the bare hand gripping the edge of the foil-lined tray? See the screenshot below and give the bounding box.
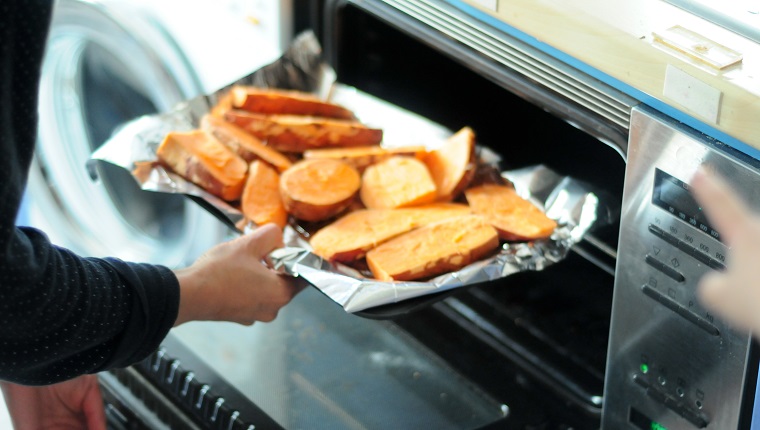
[175,224,306,325]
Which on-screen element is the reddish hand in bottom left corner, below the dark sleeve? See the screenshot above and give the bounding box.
[0,375,106,430]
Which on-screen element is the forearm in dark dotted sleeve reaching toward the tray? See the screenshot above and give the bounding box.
[0,229,179,385]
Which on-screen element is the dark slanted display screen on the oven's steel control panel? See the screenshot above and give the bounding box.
[652,169,720,240]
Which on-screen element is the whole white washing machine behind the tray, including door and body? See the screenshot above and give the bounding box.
[23,0,292,268]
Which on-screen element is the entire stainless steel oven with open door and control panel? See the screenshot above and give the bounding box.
[95,0,760,430]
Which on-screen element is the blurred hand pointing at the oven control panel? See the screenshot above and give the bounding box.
[692,169,760,335]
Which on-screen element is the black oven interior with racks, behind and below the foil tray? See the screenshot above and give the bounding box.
[324,4,625,428]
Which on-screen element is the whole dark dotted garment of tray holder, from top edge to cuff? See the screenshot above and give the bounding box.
[0,0,179,385]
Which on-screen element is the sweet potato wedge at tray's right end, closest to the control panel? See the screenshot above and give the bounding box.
[464,184,557,241]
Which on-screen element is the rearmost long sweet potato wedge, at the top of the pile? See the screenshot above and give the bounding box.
[231,85,356,119]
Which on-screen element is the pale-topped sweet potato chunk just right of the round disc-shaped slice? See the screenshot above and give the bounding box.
[360,156,436,209]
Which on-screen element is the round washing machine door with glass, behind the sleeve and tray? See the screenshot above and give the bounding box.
[25,0,230,267]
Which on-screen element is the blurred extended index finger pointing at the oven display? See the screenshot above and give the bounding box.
[691,168,749,244]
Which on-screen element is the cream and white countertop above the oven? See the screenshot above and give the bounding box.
[465,0,760,156]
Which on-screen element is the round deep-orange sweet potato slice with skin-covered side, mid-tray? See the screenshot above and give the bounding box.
[280,160,361,221]
